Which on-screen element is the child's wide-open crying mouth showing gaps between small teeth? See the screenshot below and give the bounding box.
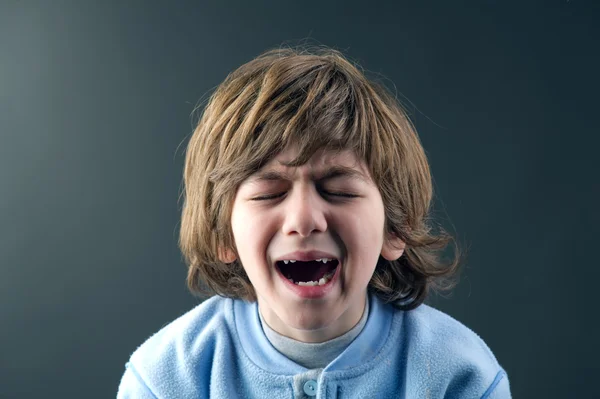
[276,258,339,286]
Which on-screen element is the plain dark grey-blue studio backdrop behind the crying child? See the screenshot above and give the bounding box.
[0,0,600,398]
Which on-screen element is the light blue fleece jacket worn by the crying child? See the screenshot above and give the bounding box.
[117,295,511,399]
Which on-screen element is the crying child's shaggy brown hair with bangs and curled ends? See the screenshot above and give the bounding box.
[179,48,460,309]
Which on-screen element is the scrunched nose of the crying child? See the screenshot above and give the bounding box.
[282,186,327,237]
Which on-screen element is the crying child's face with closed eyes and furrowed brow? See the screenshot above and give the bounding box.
[231,148,403,342]
